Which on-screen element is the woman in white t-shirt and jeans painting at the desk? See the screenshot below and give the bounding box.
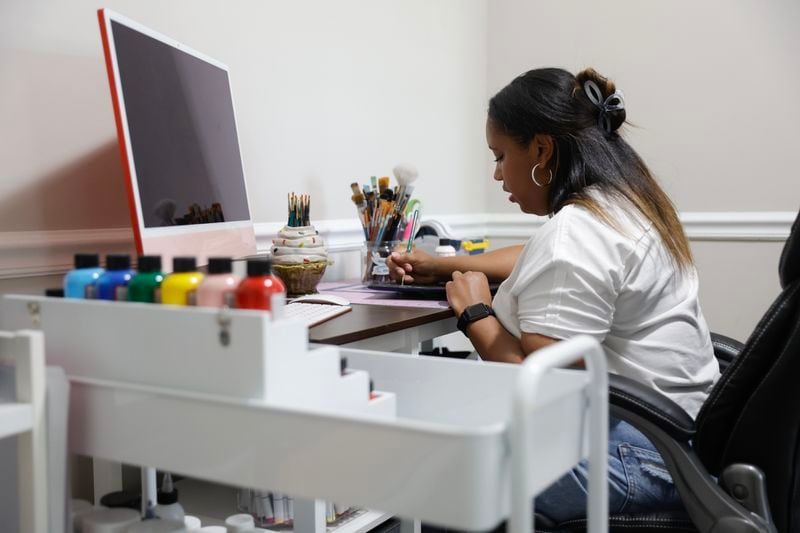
[388,68,719,522]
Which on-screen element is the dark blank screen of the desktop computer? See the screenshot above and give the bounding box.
[111,20,250,228]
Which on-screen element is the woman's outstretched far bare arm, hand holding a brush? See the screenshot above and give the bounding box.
[386,245,523,283]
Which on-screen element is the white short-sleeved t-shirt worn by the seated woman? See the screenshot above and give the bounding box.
[492,191,719,417]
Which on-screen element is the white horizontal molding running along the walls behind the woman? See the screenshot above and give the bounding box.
[0,211,796,279]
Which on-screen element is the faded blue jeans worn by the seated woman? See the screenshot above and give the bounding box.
[534,417,683,523]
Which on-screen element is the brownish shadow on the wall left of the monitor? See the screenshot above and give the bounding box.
[0,139,131,231]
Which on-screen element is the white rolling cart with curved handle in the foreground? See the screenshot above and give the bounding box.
[0,296,608,533]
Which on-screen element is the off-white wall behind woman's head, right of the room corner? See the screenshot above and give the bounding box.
[487,0,800,216]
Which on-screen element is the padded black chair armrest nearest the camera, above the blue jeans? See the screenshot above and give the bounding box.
[608,374,695,442]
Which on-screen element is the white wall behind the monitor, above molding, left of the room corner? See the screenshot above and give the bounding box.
[0,0,487,232]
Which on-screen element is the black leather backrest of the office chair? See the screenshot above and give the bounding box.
[694,211,800,533]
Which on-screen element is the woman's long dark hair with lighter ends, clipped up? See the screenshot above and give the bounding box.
[489,68,693,270]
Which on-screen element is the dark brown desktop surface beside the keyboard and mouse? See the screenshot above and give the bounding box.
[308,304,453,345]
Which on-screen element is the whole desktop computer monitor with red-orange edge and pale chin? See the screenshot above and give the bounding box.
[97,9,256,270]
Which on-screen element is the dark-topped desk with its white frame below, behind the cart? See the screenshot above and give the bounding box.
[308,304,456,354]
